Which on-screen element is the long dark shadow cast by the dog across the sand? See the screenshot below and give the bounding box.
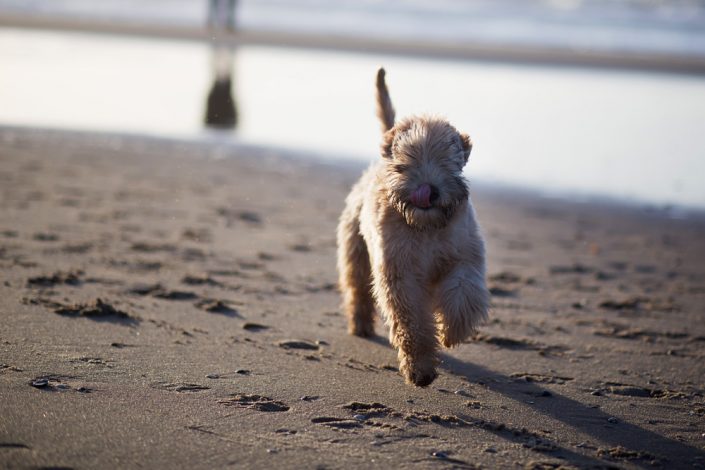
[442,354,705,468]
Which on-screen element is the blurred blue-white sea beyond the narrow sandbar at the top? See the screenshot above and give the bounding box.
[0,0,705,57]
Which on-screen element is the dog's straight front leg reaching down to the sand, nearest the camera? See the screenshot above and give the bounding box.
[373,258,438,387]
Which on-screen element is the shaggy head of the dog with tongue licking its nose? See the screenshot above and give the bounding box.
[382,117,472,230]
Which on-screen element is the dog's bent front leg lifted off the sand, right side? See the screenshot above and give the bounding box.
[435,266,490,348]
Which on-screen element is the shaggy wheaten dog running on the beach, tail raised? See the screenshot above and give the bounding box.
[338,69,489,386]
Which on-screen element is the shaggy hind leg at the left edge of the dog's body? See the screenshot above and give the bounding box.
[338,205,375,337]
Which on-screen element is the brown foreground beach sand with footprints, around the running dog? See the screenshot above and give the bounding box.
[0,128,705,468]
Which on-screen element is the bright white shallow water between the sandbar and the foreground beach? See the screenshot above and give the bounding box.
[0,9,705,208]
